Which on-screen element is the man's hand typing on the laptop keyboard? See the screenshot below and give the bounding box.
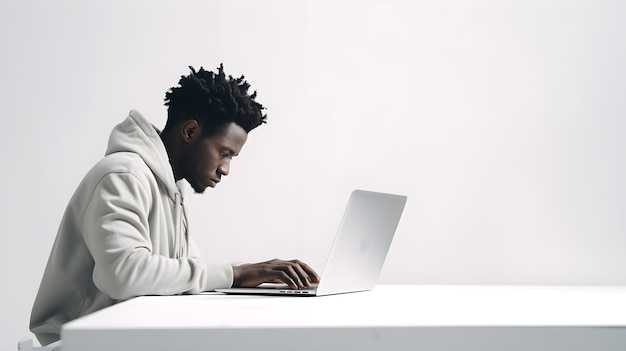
[233,259,320,289]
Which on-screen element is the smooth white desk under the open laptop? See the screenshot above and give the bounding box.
[62,285,626,351]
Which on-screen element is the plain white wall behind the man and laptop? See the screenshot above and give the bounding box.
[0,0,626,350]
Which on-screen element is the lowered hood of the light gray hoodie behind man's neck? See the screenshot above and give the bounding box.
[105,110,178,199]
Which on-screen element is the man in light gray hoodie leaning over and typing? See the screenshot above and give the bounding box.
[30,65,319,345]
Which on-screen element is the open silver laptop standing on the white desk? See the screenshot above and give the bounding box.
[215,190,407,296]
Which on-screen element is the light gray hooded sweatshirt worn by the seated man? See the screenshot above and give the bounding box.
[30,111,233,345]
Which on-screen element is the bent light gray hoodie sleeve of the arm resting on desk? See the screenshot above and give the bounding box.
[83,172,232,300]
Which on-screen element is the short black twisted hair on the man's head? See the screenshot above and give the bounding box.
[165,64,267,135]
